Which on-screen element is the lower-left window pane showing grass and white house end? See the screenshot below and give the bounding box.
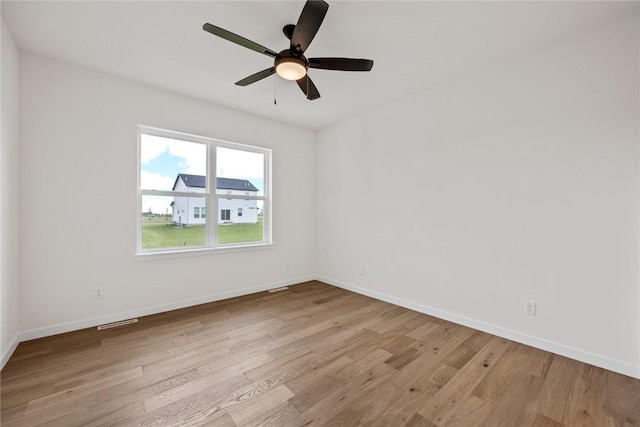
[141,196,206,249]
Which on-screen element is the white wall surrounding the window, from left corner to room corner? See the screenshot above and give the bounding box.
[20,54,315,338]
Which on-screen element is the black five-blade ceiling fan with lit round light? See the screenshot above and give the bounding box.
[202,0,373,100]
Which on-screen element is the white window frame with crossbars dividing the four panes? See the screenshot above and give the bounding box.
[135,125,273,259]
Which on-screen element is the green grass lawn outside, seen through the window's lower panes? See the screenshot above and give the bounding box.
[142,216,263,249]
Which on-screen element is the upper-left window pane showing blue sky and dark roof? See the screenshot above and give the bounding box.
[140,134,207,193]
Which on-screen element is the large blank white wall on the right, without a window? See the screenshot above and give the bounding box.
[316,15,640,377]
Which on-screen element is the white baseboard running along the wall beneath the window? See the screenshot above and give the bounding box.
[15,276,315,344]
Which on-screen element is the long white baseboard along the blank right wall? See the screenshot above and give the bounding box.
[316,276,640,379]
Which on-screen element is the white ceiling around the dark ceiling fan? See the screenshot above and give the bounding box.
[2,0,638,130]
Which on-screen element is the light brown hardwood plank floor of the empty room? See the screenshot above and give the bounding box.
[0,282,640,427]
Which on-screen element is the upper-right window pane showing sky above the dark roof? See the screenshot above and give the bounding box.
[216,147,264,196]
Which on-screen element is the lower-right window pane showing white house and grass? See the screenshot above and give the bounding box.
[218,198,264,244]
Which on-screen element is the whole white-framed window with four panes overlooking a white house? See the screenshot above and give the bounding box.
[137,126,271,254]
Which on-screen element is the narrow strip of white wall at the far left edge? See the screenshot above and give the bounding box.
[0,20,20,367]
